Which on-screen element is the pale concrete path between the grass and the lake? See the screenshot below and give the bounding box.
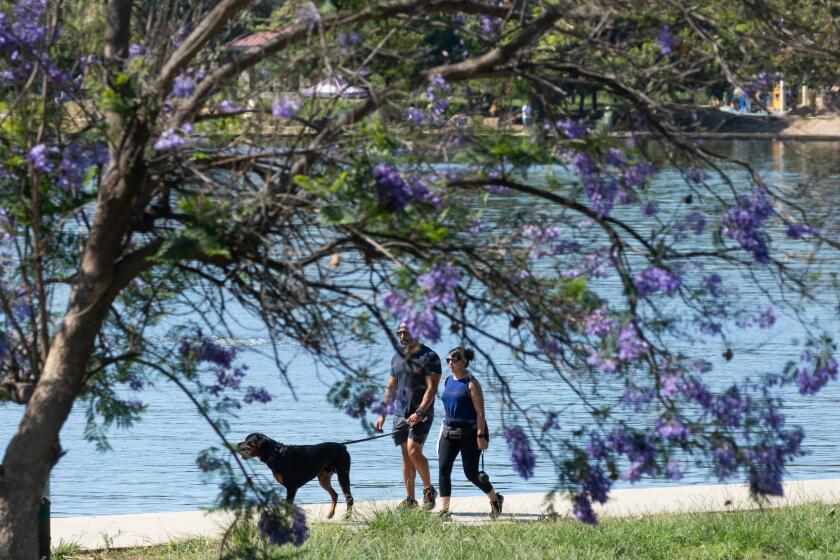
[51,479,840,549]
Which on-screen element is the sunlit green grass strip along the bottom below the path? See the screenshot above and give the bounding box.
[53,504,840,560]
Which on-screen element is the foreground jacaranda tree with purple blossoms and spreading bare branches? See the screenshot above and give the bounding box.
[0,0,838,559]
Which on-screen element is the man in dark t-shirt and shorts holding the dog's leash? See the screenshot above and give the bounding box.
[374,323,441,509]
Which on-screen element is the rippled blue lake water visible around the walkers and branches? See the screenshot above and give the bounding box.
[0,141,840,517]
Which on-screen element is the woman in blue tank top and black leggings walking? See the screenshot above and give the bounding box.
[438,346,504,518]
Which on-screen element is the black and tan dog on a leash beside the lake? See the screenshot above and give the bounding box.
[236,433,353,519]
